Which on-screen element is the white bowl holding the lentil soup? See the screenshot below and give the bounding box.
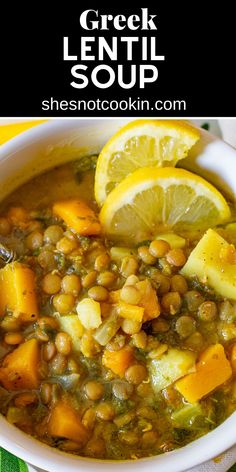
[0,119,236,472]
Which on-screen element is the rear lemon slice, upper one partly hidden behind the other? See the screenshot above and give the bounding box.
[95,120,200,205]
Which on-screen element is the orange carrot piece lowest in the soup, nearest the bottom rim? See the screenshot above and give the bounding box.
[47,400,89,445]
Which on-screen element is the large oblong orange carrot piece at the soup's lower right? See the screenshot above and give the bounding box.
[175,344,232,403]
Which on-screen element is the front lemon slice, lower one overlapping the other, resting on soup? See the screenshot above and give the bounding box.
[100,167,230,242]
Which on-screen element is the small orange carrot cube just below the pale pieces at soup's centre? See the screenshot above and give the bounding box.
[102,346,134,377]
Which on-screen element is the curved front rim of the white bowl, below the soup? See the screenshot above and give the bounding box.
[0,412,236,472]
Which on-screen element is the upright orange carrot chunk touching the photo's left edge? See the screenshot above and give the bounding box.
[0,262,38,322]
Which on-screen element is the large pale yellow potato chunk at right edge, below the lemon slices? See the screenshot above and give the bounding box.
[181,229,236,300]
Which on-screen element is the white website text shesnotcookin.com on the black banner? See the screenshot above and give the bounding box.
[41,97,187,112]
